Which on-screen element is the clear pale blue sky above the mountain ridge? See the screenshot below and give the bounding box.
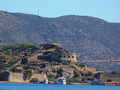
[0,0,120,22]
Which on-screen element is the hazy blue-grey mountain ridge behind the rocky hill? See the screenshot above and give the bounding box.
[0,11,120,60]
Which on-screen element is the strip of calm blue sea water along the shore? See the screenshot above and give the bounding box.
[0,83,120,90]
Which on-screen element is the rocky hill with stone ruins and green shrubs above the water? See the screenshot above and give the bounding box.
[0,43,104,83]
